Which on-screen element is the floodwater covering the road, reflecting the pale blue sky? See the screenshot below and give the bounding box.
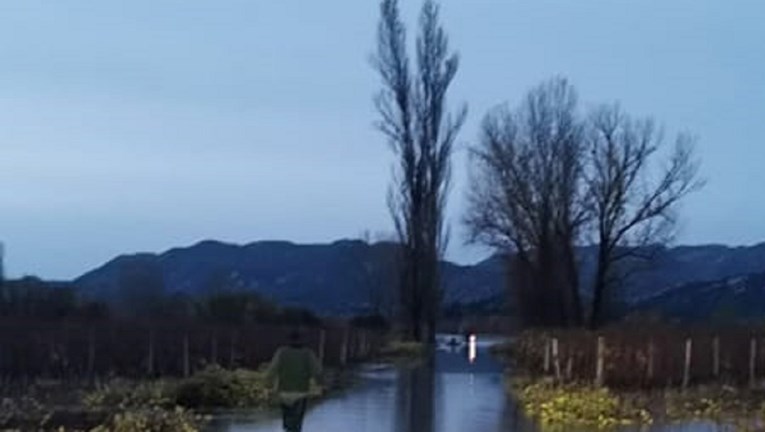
[204,336,729,432]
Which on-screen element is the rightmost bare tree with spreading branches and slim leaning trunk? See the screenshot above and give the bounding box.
[587,106,703,327]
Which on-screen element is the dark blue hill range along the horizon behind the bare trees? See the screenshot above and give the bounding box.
[74,240,765,315]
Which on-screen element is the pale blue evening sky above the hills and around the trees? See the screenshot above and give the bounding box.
[0,0,765,279]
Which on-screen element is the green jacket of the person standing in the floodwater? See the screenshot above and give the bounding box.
[266,347,321,393]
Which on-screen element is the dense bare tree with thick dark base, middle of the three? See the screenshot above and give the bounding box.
[465,78,587,325]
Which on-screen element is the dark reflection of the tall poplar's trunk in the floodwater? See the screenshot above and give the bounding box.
[391,355,436,432]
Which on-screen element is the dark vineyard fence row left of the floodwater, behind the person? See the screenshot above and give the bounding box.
[0,320,383,382]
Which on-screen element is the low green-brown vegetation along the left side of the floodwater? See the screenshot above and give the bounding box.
[0,365,348,432]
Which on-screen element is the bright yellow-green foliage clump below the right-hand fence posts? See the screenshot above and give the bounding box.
[514,382,653,430]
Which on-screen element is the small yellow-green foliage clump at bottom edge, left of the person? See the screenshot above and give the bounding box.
[90,408,200,432]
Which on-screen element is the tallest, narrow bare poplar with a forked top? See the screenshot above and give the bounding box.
[373,0,466,340]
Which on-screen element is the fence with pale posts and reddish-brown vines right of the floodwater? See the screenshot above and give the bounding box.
[514,326,765,387]
